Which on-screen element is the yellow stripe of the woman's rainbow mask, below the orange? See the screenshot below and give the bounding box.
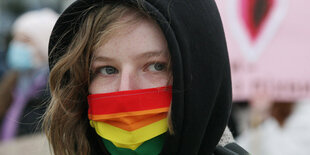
[90,118,168,150]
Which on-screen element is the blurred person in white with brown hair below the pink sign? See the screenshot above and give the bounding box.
[237,96,310,155]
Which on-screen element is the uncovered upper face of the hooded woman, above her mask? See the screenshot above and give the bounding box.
[89,19,170,94]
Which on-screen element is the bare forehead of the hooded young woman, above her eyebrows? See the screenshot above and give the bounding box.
[94,16,168,57]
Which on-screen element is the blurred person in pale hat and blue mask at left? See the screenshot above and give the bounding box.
[0,8,58,141]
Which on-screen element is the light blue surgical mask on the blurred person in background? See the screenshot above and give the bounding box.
[7,41,34,70]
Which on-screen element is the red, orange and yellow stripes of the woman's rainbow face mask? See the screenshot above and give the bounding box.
[88,86,172,150]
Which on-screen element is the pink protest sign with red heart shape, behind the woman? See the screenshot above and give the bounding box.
[216,0,310,101]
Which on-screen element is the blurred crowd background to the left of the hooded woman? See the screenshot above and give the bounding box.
[0,0,72,155]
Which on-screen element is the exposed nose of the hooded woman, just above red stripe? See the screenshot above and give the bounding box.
[118,70,141,91]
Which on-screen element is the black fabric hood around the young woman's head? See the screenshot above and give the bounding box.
[49,0,232,155]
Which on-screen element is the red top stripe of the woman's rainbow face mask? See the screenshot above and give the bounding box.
[87,86,172,116]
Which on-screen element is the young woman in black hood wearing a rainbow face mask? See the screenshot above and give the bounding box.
[44,0,246,155]
